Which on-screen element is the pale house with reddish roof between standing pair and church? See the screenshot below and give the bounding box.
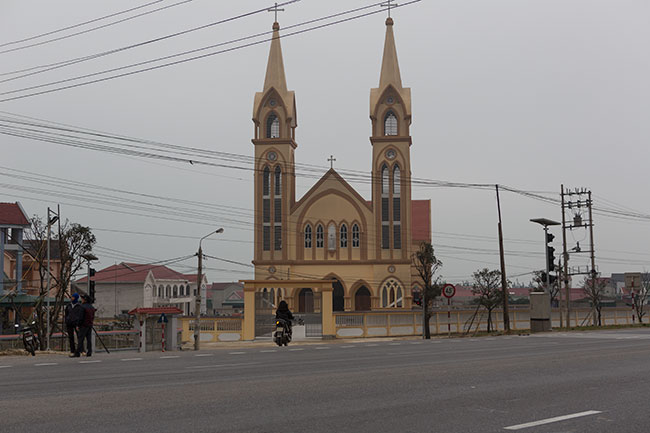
[75,263,207,317]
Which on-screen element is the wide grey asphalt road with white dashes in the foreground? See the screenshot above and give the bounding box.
[0,329,650,433]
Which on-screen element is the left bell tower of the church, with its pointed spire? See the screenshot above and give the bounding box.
[252,22,297,260]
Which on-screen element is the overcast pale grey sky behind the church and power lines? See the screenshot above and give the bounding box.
[0,0,650,282]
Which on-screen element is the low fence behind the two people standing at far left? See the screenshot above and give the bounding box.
[0,329,138,352]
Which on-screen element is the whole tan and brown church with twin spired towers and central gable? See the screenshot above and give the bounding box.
[252,18,431,312]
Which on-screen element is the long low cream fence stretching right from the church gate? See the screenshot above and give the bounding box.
[334,308,634,338]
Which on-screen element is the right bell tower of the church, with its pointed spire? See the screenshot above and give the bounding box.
[370,17,411,260]
